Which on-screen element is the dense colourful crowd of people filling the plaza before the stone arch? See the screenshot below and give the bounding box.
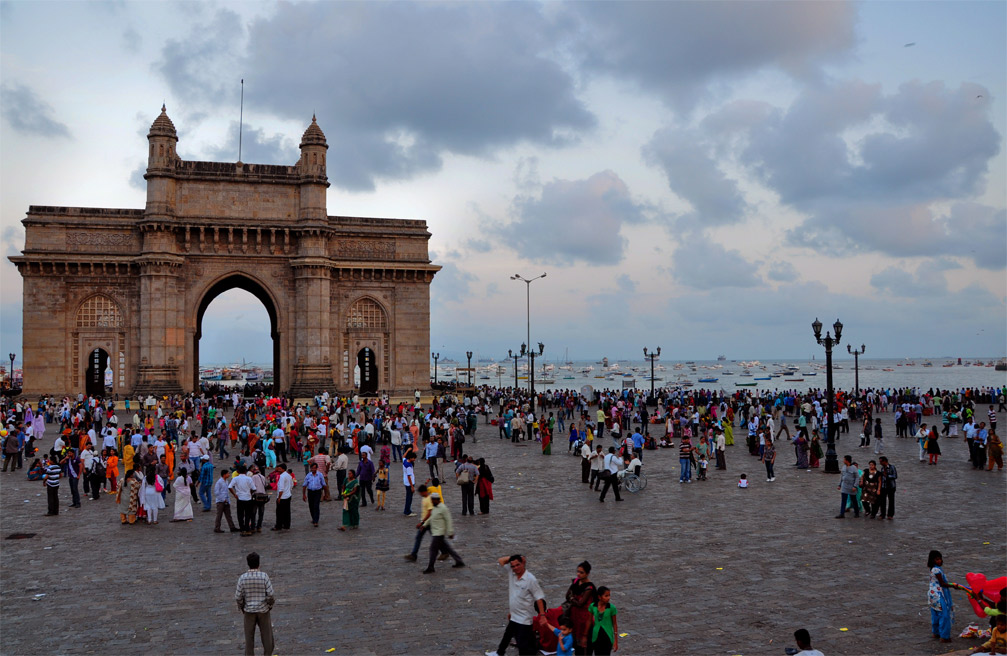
[0,387,1005,654]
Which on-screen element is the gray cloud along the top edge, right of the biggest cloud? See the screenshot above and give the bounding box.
[567,2,857,109]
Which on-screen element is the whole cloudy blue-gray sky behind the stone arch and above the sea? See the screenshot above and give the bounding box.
[0,2,1007,362]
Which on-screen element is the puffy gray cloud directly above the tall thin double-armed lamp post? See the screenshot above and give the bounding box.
[495,170,646,266]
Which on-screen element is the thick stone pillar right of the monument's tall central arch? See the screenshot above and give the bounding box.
[290,257,335,397]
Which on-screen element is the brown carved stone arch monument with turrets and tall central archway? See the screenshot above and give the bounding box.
[10,107,440,396]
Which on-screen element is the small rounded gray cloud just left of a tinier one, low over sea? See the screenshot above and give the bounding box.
[672,235,762,290]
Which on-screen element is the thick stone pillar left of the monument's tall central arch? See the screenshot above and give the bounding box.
[134,254,185,396]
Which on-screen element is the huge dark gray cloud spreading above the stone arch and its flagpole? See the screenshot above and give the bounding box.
[158,3,595,189]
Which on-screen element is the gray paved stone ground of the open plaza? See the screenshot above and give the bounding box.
[0,415,1007,656]
